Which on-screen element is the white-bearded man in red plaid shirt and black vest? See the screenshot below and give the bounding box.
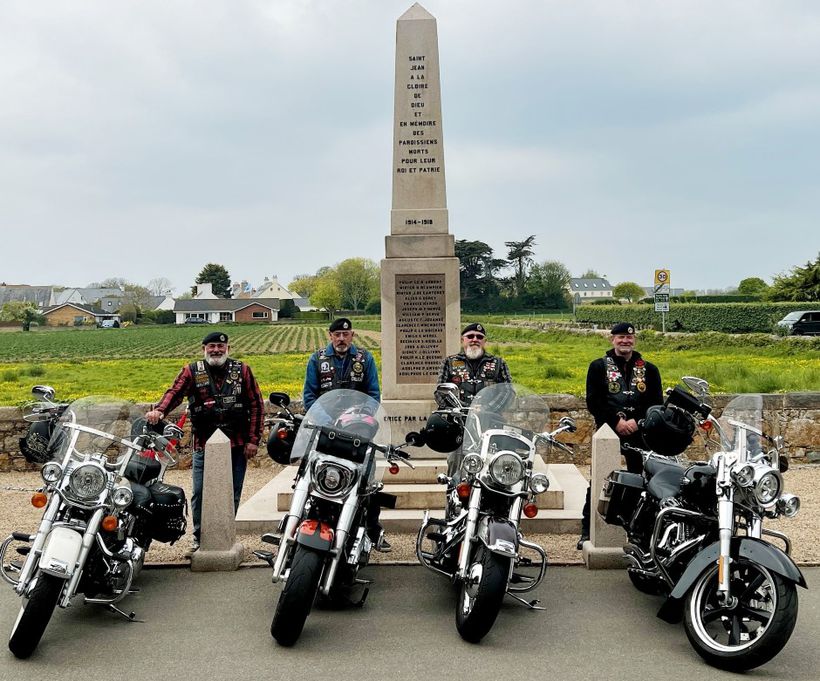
[145,331,265,551]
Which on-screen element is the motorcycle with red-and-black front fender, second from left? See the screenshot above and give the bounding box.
[254,389,422,646]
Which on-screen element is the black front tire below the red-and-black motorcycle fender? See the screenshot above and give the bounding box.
[270,546,324,646]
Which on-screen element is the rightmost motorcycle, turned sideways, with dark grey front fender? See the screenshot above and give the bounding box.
[598,377,806,671]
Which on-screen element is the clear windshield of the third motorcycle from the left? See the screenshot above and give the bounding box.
[463,383,550,452]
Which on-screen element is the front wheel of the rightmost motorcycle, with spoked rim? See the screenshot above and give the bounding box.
[684,558,797,672]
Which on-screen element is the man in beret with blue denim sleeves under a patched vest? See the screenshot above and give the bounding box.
[302,317,381,411]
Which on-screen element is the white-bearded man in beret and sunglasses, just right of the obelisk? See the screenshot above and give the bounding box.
[438,323,512,477]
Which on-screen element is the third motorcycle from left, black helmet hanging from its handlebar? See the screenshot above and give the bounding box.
[416,383,575,643]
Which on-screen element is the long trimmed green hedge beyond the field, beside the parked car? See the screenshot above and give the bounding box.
[575,302,818,333]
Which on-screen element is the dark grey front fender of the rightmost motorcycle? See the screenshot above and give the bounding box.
[657,537,808,623]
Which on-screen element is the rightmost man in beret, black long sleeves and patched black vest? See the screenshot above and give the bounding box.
[578,322,663,549]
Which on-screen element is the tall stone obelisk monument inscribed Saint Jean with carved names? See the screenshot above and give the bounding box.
[381,3,461,448]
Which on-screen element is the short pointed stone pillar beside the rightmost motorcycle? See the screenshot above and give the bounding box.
[583,424,626,570]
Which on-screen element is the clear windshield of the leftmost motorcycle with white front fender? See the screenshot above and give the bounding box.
[49,395,145,466]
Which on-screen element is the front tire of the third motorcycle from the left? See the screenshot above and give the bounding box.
[456,544,510,643]
